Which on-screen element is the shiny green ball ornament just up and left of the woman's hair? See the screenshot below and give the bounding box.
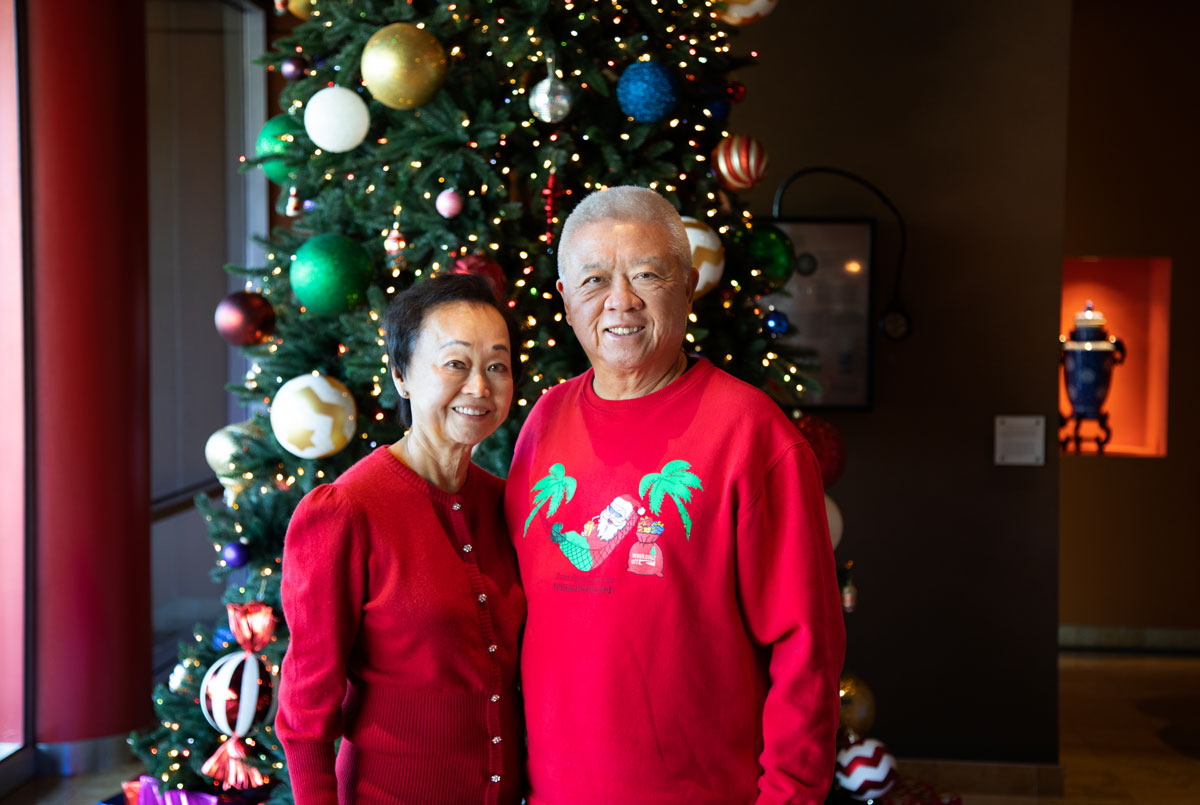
[290,233,371,316]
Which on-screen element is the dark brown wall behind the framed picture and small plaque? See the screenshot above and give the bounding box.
[731,0,1069,762]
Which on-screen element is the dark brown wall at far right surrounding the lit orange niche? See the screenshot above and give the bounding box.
[1060,0,1200,629]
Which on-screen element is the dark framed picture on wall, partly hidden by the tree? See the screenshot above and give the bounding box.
[763,218,875,408]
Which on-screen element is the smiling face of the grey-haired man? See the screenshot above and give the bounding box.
[558,220,697,377]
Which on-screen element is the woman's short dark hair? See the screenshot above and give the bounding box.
[383,274,521,427]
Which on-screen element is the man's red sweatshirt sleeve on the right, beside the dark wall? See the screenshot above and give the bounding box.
[737,443,846,805]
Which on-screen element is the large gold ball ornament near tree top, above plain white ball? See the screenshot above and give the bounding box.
[362,23,446,109]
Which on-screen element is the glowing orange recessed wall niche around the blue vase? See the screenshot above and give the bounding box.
[1058,257,1171,456]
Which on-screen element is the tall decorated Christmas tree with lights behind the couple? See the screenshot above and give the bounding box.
[131,0,809,801]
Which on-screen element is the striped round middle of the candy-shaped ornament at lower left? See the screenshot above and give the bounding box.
[200,651,275,738]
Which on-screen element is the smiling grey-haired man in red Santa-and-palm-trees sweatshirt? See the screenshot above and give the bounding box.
[505,187,845,805]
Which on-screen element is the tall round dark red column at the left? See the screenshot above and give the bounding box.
[25,0,151,743]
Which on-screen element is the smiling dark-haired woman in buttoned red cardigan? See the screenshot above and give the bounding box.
[276,276,526,805]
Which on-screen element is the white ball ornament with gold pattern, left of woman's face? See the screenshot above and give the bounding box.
[271,372,358,458]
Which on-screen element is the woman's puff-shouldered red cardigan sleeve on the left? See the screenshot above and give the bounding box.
[275,485,367,805]
